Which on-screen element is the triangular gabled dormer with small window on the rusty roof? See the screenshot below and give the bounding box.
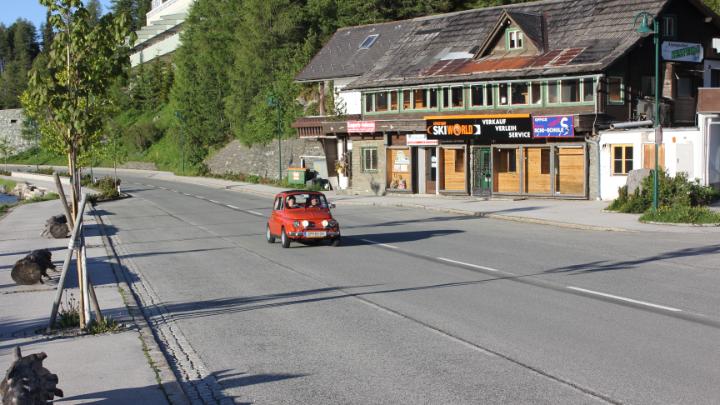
[475,10,547,59]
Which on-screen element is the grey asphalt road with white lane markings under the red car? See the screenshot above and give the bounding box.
[99,171,720,404]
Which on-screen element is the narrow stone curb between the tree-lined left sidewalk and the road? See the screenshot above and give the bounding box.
[92,208,191,405]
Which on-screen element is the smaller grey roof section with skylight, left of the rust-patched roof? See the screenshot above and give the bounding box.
[295,21,409,81]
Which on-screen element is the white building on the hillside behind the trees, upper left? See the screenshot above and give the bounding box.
[130,0,195,67]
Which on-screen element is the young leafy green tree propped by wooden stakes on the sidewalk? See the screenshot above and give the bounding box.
[22,0,130,216]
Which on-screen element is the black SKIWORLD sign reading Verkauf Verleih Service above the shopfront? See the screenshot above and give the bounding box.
[425,114,532,142]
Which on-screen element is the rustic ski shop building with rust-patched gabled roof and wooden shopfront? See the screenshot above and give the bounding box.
[299,0,720,198]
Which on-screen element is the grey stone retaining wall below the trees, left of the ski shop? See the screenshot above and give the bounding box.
[205,138,325,179]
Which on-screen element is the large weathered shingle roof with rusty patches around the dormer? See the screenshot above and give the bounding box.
[348,0,671,88]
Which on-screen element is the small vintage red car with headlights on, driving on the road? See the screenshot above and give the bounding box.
[265,190,340,248]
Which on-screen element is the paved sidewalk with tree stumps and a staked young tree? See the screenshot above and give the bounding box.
[0,200,182,404]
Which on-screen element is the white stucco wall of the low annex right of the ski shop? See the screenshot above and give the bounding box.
[600,128,706,200]
